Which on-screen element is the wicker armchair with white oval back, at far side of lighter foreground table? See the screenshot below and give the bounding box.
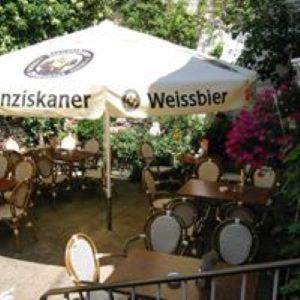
[124,210,189,254]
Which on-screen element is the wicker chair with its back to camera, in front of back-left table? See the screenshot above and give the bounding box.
[36,156,67,202]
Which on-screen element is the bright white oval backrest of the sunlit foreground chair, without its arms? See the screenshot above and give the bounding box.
[65,233,100,285]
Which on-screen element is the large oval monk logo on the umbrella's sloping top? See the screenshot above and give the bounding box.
[24,49,93,78]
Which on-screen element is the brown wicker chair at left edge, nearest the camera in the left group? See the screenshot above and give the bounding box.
[0,180,36,250]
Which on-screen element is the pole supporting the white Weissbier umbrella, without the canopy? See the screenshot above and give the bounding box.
[104,109,112,230]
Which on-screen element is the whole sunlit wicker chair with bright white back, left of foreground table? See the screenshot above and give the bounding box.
[65,233,125,300]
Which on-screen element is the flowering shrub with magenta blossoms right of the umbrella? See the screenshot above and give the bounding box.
[226,85,293,167]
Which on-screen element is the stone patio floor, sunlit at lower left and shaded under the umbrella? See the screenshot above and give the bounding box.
[0,181,148,300]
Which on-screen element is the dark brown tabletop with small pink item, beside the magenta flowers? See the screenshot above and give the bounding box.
[176,179,270,205]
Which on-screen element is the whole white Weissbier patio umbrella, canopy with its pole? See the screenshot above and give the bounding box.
[0,21,255,227]
